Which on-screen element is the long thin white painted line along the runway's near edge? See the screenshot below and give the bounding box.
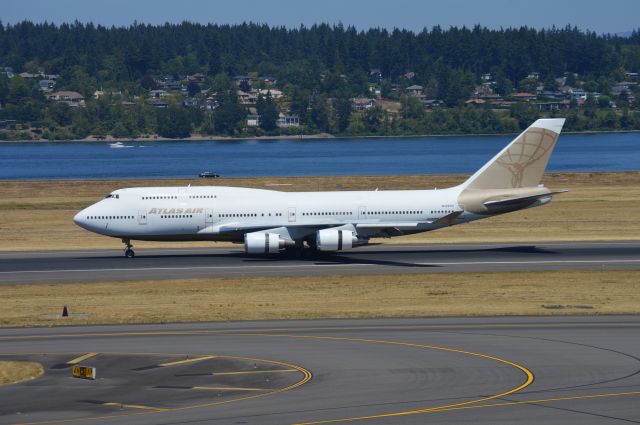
[0,259,640,275]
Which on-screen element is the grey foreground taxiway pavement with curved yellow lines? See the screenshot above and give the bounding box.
[0,317,640,425]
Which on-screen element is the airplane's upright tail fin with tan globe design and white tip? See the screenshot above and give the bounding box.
[461,118,565,190]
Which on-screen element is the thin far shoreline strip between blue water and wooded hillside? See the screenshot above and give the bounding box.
[0,130,640,144]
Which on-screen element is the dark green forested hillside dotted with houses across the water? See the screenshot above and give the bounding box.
[0,22,640,139]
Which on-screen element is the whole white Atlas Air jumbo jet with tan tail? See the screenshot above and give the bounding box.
[73,118,564,258]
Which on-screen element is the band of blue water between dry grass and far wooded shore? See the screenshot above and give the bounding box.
[0,133,640,180]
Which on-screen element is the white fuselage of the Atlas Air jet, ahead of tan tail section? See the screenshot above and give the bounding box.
[74,186,483,242]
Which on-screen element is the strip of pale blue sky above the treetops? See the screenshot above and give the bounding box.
[5,0,640,33]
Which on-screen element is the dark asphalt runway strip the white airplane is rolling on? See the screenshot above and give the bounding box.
[0,241,640,284]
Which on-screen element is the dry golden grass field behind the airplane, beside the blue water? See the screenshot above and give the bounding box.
[0,172,640,251]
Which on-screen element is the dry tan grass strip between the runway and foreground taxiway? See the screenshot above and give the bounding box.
[0,270,640,326]
